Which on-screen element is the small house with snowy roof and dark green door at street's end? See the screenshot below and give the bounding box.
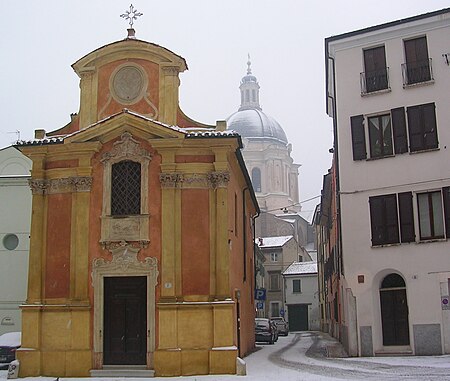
[282,262,320,331]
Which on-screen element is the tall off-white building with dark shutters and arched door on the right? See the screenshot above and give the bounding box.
[325,8,450,356]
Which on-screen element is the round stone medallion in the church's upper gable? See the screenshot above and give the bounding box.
[111,64,147,104]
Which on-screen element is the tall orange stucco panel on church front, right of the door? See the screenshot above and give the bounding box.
[181,189,210,295]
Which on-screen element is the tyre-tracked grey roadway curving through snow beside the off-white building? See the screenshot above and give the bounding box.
[263,332,450,381]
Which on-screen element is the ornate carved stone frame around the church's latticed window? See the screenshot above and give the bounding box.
[100,132,152,246]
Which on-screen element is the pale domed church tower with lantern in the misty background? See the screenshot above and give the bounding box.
[227,59,301,214]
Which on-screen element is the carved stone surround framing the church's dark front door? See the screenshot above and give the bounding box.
[91,241,159,377]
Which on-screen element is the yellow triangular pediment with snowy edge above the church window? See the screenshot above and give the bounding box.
[64,110,185,144]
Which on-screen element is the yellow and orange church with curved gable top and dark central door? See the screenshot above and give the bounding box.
[17,29,258,377]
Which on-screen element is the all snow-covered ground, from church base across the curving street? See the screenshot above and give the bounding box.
[0,332,450,381]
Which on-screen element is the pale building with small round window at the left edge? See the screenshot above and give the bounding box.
[0,147,31,334]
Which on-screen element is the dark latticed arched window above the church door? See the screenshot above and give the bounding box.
[111,160,141,216]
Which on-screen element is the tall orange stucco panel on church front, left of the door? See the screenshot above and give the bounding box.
[45,193,72,298]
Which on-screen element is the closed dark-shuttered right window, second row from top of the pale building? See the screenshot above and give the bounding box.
[407,103,438,152]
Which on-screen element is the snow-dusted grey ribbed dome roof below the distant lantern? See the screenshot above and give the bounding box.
[227,108,288,144]
